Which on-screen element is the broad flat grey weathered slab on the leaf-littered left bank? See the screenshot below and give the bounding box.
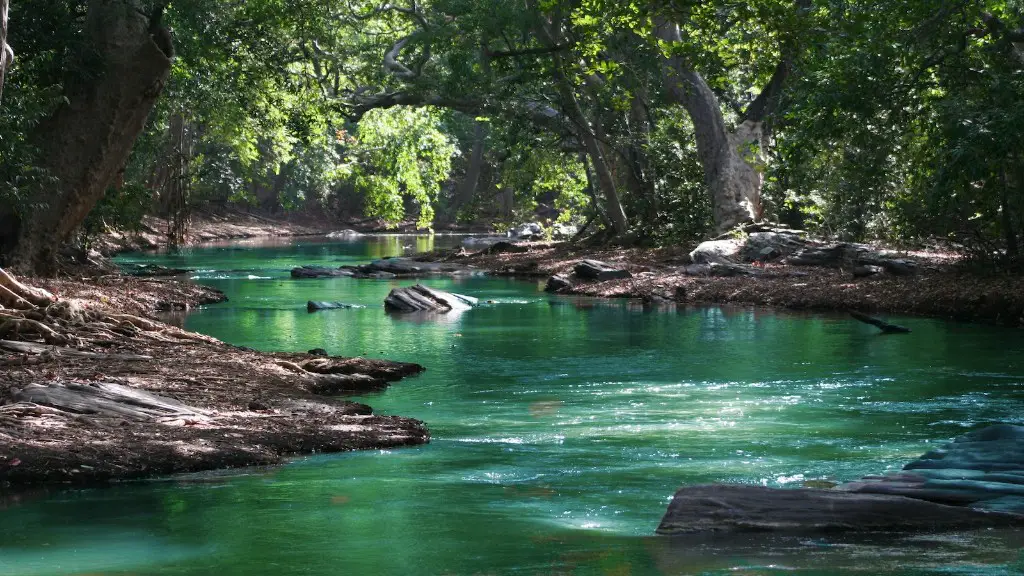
[14,382,208,420]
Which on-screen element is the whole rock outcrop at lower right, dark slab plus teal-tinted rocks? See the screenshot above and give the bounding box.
[657,424,1024,535]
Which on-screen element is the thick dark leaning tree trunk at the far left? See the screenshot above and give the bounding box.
[5,0,173,274]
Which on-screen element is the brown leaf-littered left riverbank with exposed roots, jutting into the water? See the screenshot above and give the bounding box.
[0,268,429,487]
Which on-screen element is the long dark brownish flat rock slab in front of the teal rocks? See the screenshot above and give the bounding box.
[657,485,1024,535]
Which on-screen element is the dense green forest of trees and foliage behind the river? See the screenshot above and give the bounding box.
[0,0,1024,273]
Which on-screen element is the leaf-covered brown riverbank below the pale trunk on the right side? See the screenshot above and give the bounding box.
[424,238,1024,327]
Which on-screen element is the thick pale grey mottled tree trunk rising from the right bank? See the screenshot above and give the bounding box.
[654,22,763,234]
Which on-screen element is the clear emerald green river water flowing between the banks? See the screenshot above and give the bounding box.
[0,237,1024,576]
